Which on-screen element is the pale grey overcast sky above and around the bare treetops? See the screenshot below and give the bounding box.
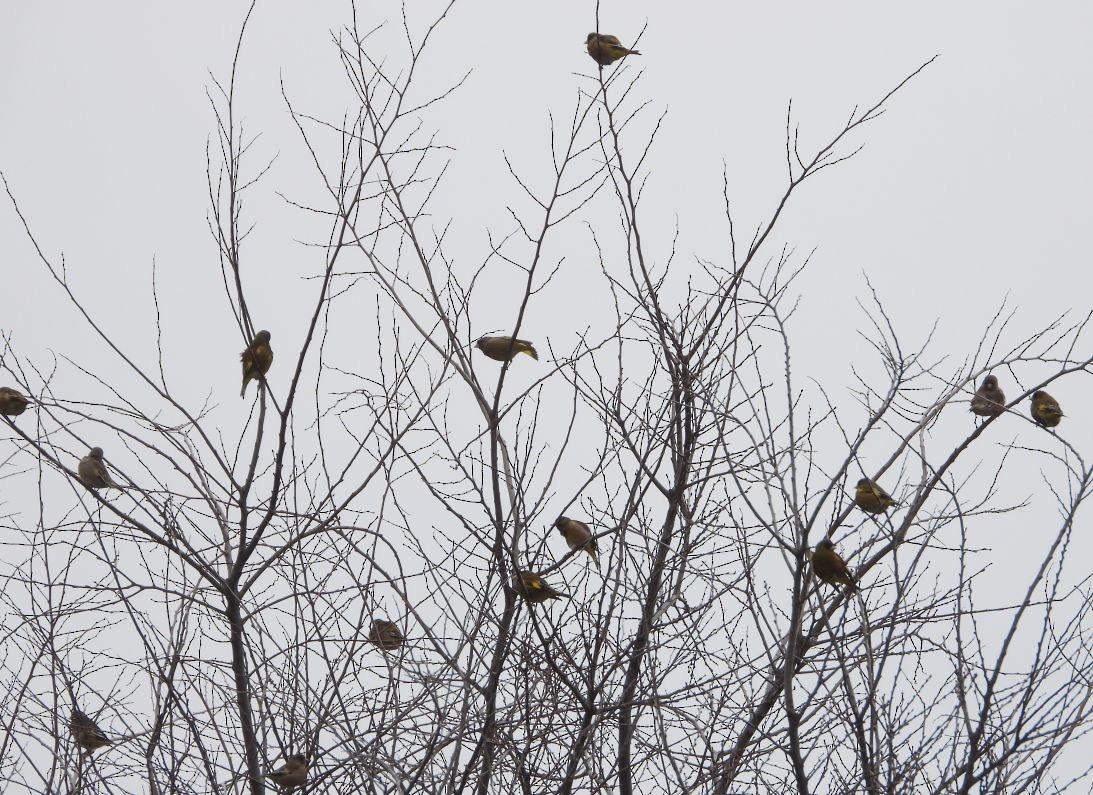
[0,0,1093,791]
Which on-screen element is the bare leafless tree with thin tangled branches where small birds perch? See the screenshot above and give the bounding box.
[0,5,1093,795]
